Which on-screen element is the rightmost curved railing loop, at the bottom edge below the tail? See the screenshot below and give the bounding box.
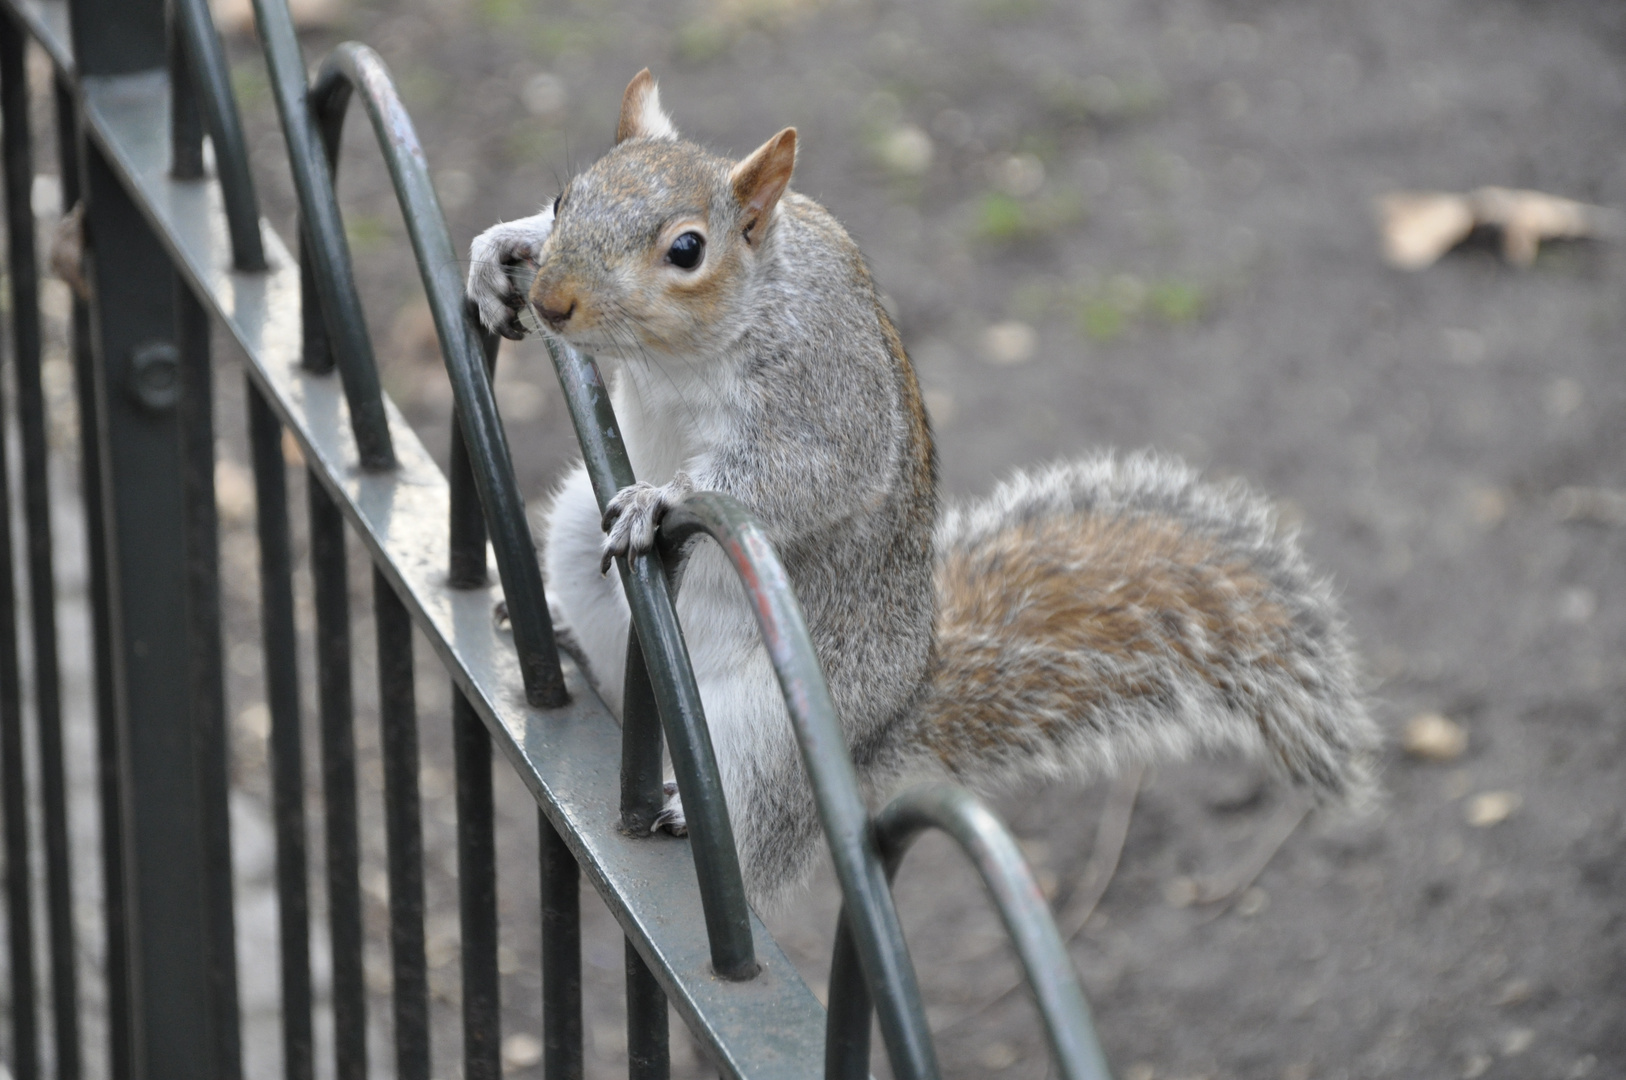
[824,784,1111,1080]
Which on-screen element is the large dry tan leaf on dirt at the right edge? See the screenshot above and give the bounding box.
[1377,187,1626,270]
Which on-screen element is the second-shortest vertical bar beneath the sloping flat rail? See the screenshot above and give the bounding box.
[537,810,582,1080]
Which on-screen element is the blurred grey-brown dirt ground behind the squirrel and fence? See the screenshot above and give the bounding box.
[19,0,1626,1080]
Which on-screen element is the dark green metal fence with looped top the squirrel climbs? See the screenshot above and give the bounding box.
[0,0,1106,1080]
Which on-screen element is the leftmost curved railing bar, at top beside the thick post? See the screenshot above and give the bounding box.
[172,0,265,270]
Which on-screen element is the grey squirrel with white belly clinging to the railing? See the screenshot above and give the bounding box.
[467,68,1377,904]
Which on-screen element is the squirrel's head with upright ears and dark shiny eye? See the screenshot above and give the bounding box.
[530,68,797,358]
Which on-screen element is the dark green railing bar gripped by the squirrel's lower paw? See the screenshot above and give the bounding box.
[545,337,758,979]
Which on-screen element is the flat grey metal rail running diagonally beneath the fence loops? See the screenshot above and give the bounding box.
[5,0,824,1078]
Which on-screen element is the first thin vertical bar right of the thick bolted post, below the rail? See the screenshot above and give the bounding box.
[247,381,314,1080]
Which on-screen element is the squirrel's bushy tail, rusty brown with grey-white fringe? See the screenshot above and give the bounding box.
[914,454,1377,800]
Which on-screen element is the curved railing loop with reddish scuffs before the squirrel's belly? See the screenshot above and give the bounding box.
[660,491,938,1078]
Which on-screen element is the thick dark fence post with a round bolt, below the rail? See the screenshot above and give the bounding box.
[75,130,222,1080]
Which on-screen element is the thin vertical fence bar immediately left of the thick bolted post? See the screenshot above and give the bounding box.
[55,80,132,1080]
